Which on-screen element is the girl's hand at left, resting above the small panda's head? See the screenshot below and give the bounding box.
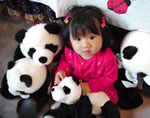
[54,71,67,85]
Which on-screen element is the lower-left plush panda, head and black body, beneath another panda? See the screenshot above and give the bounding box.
[1,58,50,118]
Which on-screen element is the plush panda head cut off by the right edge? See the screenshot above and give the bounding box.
[120,31,150,73]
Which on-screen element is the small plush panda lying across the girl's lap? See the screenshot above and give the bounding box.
[43,76,120,118]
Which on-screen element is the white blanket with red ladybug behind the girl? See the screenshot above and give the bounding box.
[29,0,150,32]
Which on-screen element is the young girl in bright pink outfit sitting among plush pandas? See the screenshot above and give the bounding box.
[54,6,118,104]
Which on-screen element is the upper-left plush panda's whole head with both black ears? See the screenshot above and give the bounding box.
[15,23,62,65]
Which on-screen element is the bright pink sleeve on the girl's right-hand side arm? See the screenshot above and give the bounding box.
[88,56,118,92]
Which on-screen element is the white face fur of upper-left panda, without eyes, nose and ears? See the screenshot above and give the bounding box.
[20,23,62,65]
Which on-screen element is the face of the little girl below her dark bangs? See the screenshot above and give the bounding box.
[70,31,103,59]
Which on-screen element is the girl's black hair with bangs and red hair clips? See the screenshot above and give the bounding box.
[62,6,111,50]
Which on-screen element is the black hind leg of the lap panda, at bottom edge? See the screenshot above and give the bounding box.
[101,101,120,118]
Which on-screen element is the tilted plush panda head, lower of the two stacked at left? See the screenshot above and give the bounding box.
[6,58,47,98]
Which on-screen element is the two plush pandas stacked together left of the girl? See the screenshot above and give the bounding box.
[1,23,62,118]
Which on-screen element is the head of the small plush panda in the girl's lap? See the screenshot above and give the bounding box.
[51,76,82,104]
